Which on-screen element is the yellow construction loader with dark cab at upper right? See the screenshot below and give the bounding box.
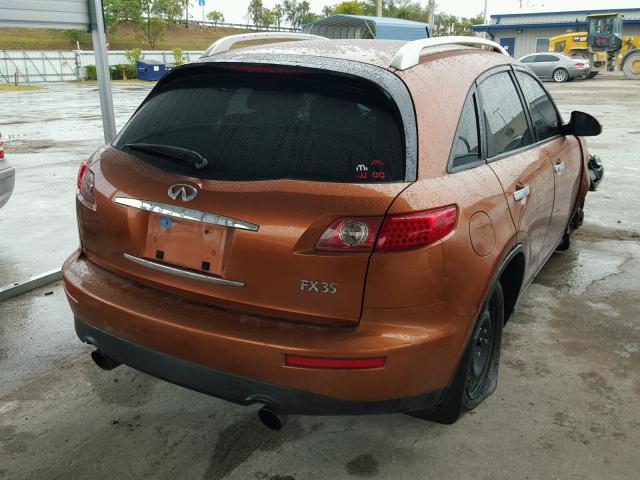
[549,13,640,80]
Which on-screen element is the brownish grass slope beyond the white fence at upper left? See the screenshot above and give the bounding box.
[0,23,248,50]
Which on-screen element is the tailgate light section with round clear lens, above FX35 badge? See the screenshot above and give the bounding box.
[316,217,382,252]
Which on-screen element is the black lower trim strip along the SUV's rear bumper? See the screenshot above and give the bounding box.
[75,318,441,415]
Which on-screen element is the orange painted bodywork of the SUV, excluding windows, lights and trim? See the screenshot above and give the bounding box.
[63,42,589,408]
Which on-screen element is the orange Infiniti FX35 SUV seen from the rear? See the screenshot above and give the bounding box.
[63,34,601,428]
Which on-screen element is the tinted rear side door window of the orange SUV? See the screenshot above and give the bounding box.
[479,72,532,157]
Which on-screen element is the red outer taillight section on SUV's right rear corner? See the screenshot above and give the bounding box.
[376,205,458,252]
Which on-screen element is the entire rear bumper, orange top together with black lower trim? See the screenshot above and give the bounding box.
[63,253,464,414]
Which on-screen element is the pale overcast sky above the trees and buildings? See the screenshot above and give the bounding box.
[191,0,640,23]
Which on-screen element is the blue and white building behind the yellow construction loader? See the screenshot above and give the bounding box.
[473,2,640,58]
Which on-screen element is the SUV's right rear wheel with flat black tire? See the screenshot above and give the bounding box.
[411,282,504,425]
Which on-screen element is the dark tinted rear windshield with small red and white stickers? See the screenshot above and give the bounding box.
[115,72,405,183]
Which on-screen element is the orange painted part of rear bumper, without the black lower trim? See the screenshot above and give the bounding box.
[64,254,468,400]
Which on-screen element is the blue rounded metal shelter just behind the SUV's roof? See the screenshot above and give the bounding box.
[302,14,430,40]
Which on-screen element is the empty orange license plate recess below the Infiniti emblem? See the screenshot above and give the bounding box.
[144,213,228,275]
